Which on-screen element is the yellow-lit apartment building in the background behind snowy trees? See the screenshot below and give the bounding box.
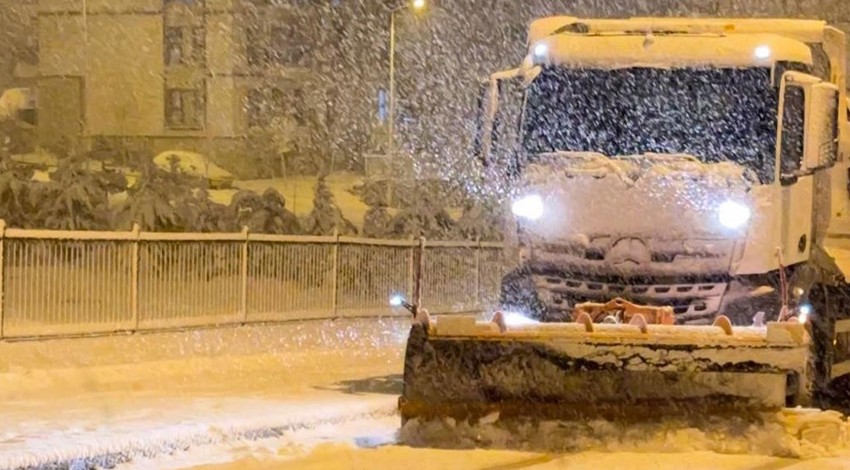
[37,0,325,168]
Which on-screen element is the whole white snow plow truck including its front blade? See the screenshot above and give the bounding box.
[399,17,850,421]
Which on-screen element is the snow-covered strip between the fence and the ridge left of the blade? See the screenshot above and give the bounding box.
[0,320,407,468]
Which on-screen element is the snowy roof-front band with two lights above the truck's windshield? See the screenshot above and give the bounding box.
[525,33,812,69]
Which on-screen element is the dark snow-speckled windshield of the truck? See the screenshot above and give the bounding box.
[521,67,778,181]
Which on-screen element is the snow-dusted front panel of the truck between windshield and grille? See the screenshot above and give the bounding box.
[516,152,762,240]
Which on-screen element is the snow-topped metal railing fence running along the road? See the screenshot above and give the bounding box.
[0,221,502,338]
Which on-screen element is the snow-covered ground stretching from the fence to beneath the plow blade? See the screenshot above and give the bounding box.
[0,319,850,470]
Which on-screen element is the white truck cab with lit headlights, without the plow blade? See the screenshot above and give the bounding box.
[476,17,850,396]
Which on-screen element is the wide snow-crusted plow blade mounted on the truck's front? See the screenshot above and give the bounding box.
[399,314,810,423]
